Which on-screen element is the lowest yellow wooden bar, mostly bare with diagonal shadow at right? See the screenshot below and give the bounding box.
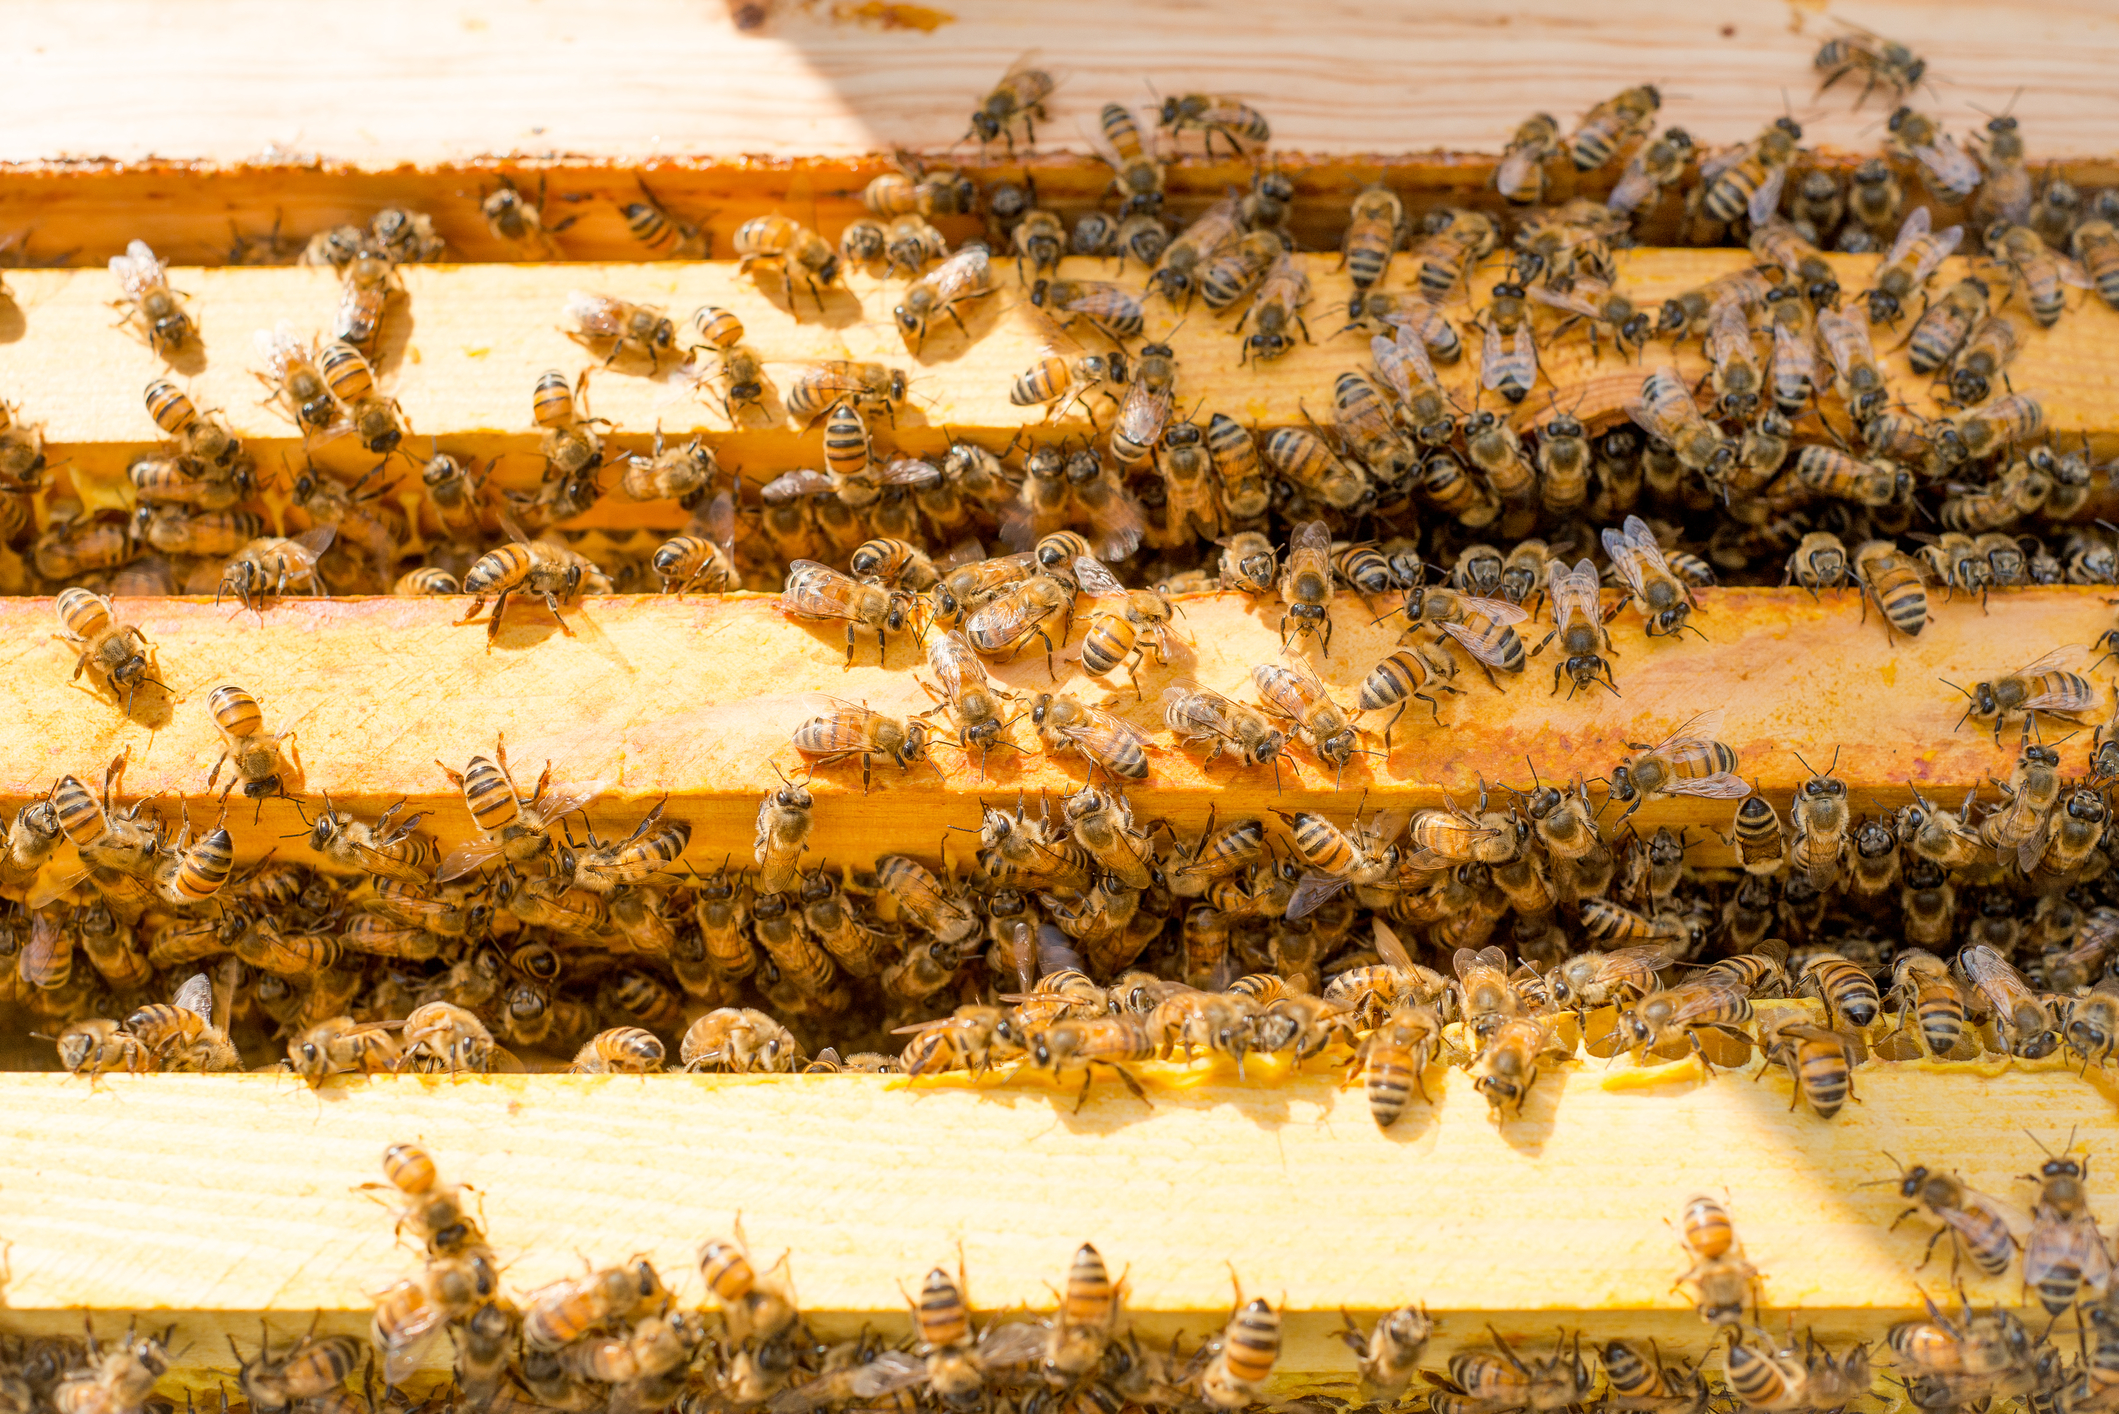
[0,1060,2119,1389]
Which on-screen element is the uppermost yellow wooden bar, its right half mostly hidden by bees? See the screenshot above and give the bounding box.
[0,250,2119,526]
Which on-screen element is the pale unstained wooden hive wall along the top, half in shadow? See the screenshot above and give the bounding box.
[0,0,2119,167]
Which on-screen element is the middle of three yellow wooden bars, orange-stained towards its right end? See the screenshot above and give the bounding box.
[0,589,2113,865]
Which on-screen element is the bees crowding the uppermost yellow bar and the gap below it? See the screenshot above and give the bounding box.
[0,32,2119,632]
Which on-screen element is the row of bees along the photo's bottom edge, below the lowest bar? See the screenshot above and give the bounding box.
[16,1170,2119,1414]
